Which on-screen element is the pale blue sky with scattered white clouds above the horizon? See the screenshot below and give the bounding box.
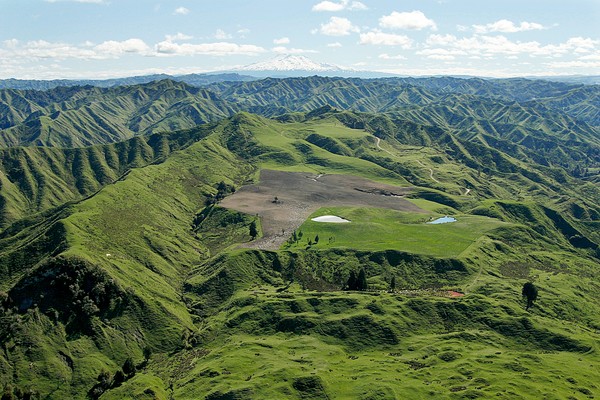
[0,0,600,79]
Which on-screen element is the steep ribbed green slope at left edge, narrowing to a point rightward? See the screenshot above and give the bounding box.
[0,125,220,228]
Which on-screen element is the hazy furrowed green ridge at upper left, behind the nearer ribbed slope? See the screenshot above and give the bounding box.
[0,80,237,147]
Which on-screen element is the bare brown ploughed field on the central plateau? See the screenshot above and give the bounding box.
[220,170,424,250]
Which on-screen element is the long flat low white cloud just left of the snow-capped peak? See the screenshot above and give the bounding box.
[155,41,266,56]
